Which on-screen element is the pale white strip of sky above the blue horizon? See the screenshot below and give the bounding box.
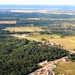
[0,0,75,5]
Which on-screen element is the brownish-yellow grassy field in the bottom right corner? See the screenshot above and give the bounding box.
[54,61,75,75]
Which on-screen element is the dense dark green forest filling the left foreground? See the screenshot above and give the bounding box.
[0,36,69,75]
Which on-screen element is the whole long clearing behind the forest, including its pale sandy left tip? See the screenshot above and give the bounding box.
[12,34,75,51]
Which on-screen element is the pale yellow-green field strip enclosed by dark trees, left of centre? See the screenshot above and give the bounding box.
[6,27,43,32]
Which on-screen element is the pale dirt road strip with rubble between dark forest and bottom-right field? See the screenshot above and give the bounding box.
[29,57,64,75]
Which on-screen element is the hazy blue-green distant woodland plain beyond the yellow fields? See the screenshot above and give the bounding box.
[0,12,75,36]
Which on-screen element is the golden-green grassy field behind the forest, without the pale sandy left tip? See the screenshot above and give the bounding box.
[30,34,75,50]
